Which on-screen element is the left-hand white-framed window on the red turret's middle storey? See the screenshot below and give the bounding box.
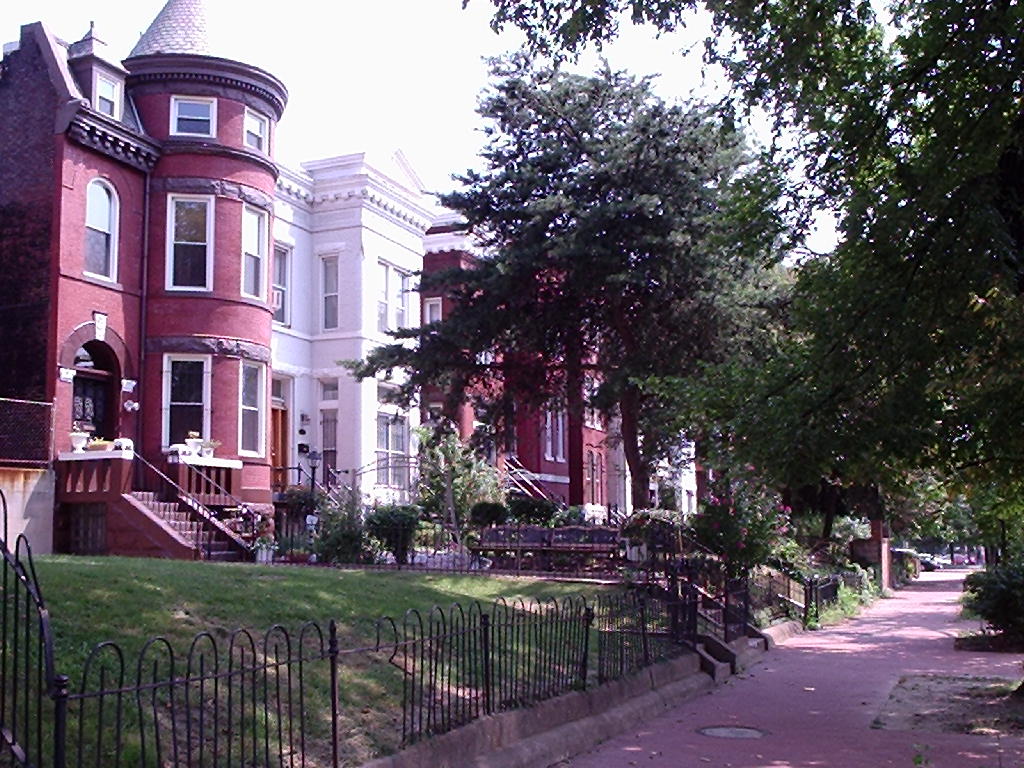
[165,195,213,291]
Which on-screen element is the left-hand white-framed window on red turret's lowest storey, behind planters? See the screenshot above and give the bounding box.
[162,354,211,446]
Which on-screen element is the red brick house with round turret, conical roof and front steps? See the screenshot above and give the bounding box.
[0,0,287,554]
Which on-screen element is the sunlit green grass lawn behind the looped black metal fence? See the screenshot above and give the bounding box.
[29,556,602,765]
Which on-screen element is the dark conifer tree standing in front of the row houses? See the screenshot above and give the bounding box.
[356,56,782,504]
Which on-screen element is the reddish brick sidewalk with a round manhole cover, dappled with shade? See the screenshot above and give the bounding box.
[561,570,1024,768]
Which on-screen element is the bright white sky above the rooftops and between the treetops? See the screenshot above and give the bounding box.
[0,0,831,247]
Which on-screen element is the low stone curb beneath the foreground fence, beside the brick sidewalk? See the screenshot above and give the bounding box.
[361,653,715,768]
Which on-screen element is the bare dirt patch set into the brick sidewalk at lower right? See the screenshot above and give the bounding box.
[871,675,1024,736]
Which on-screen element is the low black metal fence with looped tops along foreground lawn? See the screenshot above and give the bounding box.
[0,492,697,768]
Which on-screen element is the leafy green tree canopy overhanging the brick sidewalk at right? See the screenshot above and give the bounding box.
[477,0,1024,524]
